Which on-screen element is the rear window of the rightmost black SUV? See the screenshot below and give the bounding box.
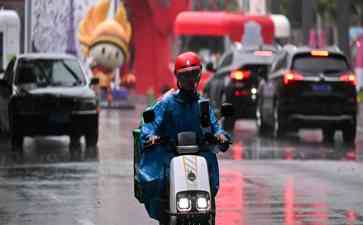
[293,55,349,76]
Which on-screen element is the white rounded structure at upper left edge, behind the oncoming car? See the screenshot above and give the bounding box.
[0,9,20,73]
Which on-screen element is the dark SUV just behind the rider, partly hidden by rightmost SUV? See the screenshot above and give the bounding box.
[204,45,278,130]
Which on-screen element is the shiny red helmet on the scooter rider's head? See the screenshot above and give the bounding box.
[174,52,202,75]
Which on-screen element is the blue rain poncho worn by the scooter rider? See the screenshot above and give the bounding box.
[138,90,228,219]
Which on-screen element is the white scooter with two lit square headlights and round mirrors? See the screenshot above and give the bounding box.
[135,101,233,225]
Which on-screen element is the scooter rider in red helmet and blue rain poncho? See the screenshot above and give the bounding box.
[137,52,230,220]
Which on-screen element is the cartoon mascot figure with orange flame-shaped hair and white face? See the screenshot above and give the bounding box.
[78,0,131,105]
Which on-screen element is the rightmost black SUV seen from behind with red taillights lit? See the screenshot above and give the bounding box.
[256,46,357,143]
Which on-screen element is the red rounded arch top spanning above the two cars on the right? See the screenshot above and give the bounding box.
[174,11,274,44]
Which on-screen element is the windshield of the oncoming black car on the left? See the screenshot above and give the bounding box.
[15,59,85,87]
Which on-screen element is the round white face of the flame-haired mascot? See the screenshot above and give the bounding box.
[90,43,125,71]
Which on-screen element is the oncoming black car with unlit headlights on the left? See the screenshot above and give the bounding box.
[0,54,99,149]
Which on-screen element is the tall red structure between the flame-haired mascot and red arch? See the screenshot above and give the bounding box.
[126,0,190,94]
